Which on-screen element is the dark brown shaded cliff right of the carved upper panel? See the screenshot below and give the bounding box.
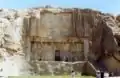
[72,9,120,60]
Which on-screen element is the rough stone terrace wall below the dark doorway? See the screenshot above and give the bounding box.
[32,61,86,75]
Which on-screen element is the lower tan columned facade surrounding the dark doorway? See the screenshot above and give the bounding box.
[31,42,84,61]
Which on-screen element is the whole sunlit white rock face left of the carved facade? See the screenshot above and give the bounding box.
[0,9,31,76]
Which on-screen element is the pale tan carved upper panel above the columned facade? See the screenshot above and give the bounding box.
[29,13,71,41]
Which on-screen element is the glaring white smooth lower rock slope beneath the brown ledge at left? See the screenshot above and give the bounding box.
[0,49,32,76]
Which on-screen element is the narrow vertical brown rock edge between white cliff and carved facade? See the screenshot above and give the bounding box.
[22,17,31,61]
